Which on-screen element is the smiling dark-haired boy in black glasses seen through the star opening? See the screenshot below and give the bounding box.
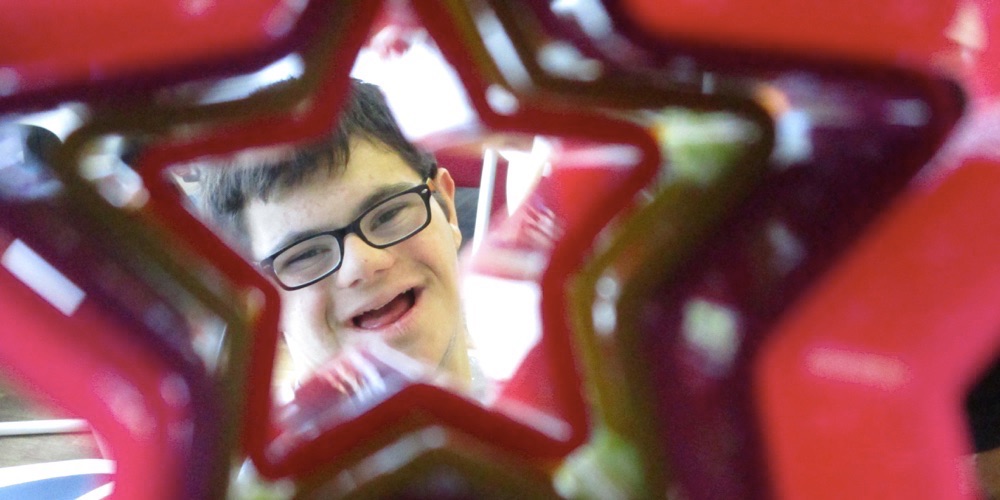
[202,80,475,398]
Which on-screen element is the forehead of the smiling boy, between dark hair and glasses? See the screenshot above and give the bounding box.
[245,139,422,259]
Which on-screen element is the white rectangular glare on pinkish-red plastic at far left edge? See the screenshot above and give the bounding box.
[0,240,86,316]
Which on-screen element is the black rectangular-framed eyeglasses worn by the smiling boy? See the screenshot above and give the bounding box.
[260,181,434,290]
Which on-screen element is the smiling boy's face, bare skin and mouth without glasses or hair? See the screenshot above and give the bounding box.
[246,140,468,379]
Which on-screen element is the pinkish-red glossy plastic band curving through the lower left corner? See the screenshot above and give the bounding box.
[0,254,194,500]
